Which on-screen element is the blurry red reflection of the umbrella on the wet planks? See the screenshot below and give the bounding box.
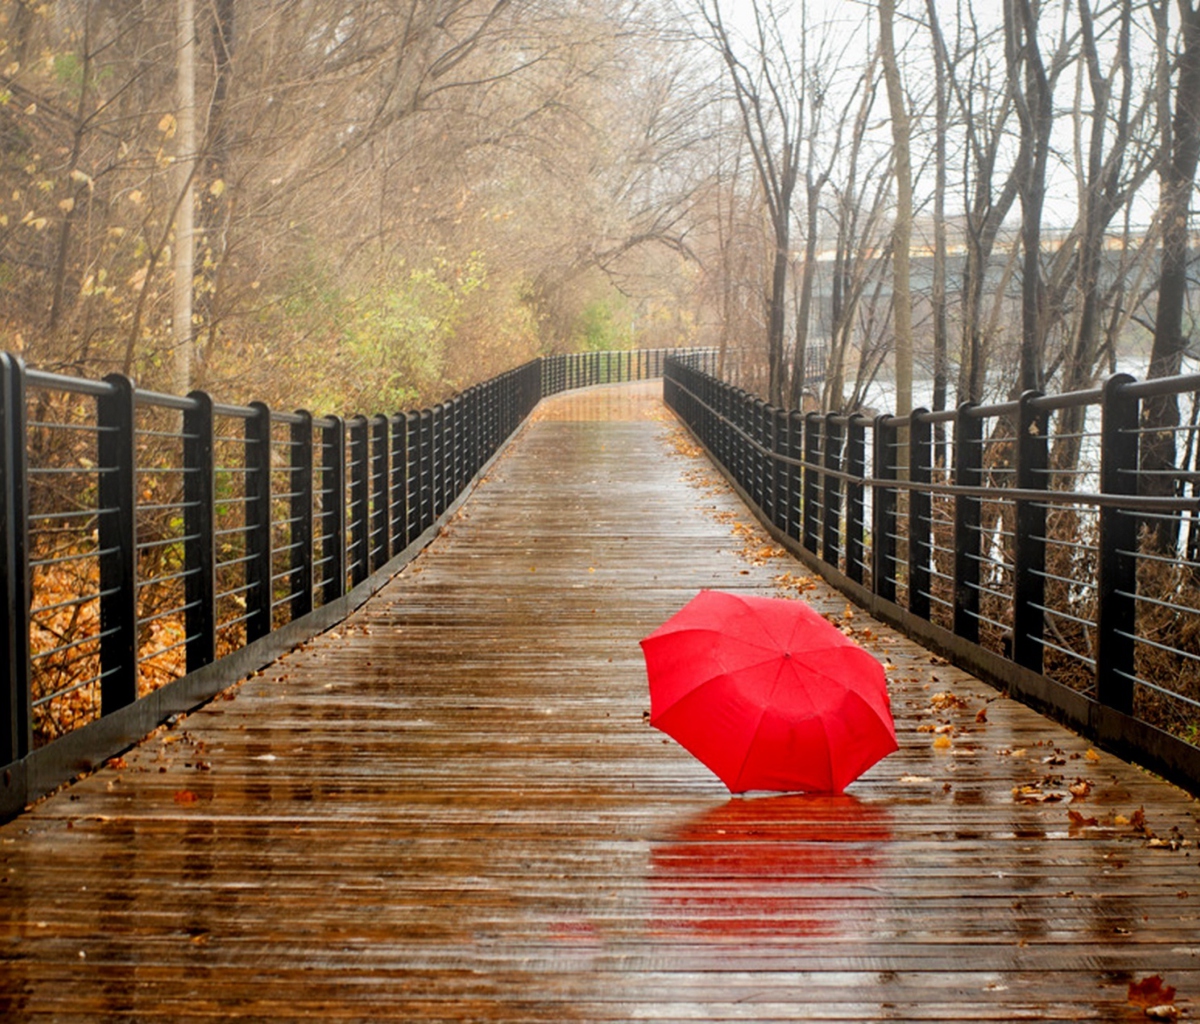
[650,794,892,939]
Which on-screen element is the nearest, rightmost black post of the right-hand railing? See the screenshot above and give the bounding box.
[1096,373,1139,714]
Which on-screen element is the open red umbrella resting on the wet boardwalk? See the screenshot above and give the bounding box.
[642,591,896,792]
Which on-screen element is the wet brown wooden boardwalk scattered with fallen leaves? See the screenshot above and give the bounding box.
[0,379,1200,1022]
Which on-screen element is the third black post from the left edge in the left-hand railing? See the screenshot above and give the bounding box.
[184,391,217,672]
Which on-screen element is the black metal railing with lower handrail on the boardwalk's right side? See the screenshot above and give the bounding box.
[664,360,1200,792]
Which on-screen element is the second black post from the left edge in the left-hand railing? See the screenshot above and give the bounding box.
[96,373,138,714]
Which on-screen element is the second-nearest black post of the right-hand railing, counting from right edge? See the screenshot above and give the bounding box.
[1013,391,1048,672]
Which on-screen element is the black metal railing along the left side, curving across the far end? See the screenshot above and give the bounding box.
[0,349,715,815]
